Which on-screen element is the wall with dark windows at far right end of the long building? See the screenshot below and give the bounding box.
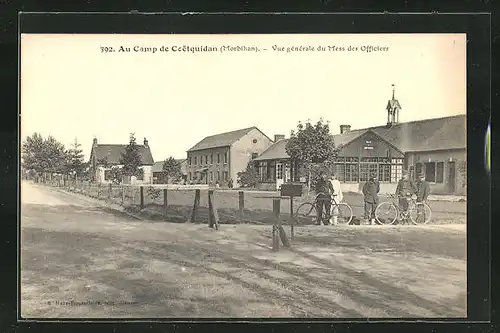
[405,149,467,195]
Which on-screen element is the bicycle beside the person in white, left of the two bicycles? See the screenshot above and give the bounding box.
[295,192,353,225]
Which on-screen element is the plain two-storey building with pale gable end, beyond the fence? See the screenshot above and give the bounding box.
[187,127,273,187]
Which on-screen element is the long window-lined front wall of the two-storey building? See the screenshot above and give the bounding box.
[186,147,230,183]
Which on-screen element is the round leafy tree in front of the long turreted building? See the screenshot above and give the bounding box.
[285,119,337,187]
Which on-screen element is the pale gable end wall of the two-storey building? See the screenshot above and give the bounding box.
[229,129,273,187]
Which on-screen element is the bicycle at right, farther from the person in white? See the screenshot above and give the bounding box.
[375,195,432,225]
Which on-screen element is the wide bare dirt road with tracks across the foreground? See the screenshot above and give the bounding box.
[21,183,466,318]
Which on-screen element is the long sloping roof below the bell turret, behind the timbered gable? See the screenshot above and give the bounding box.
[254,115,467,161]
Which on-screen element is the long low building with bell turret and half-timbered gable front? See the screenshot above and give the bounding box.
[255,87,467,195]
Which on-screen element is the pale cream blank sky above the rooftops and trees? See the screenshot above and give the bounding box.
[20,34,466,161]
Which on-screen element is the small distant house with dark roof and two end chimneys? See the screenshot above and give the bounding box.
[89,138,154,184]
